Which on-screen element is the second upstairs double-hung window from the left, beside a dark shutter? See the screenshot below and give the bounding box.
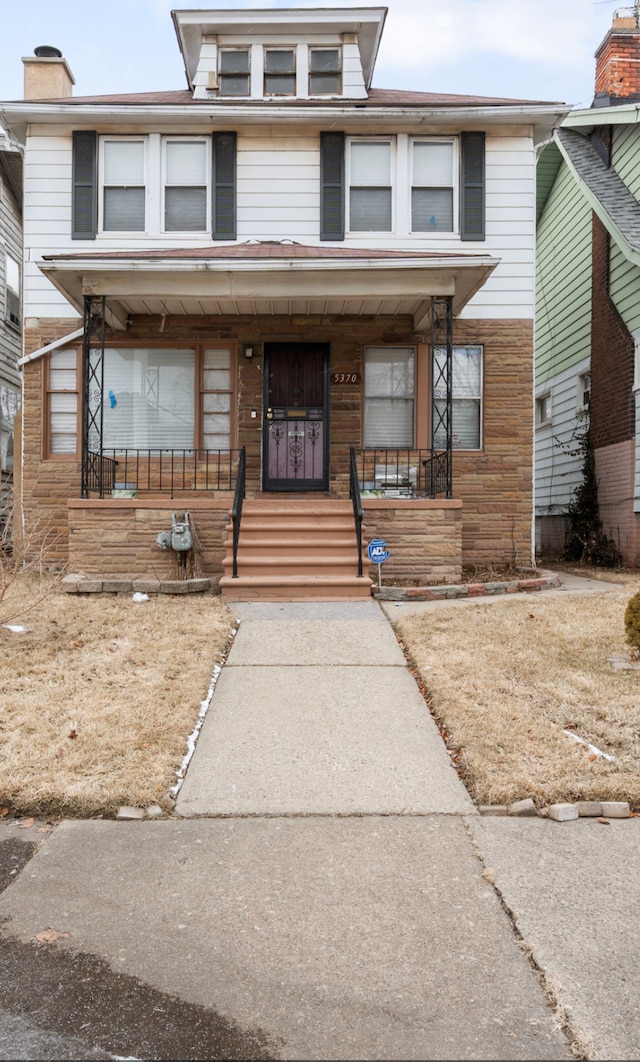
[163,139,211,233]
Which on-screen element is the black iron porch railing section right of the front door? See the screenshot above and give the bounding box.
[353,449,451,498]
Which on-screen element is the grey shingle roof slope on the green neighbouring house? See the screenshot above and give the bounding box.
[557,129,640,252]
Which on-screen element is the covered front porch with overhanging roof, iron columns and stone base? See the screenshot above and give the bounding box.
[35,243,497,598]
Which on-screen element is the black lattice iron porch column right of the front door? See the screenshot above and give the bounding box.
[431,295,453,498]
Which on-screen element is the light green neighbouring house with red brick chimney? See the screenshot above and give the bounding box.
[536,8,640,566]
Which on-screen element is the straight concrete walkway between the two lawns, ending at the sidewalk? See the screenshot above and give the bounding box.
[176,601,474,816]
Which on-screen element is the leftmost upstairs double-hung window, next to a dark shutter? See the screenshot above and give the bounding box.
[101,138,146,233]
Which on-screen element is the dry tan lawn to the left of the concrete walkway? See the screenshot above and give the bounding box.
[0,578,233,816]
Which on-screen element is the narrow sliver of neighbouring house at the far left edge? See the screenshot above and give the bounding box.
[0,127,22,509]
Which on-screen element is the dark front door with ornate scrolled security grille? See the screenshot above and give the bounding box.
[262,343,329,491]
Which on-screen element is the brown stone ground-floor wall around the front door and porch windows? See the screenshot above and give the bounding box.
[21,316,533,567]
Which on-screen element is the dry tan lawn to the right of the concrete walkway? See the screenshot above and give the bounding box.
[393,569,640,809]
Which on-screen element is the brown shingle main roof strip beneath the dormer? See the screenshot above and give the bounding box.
[13,88,558,109]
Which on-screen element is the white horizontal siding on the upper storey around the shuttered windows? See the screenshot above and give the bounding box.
[24,123,535,320]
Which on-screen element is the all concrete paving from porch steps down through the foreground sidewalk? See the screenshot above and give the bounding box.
[0,601,640,1059]
